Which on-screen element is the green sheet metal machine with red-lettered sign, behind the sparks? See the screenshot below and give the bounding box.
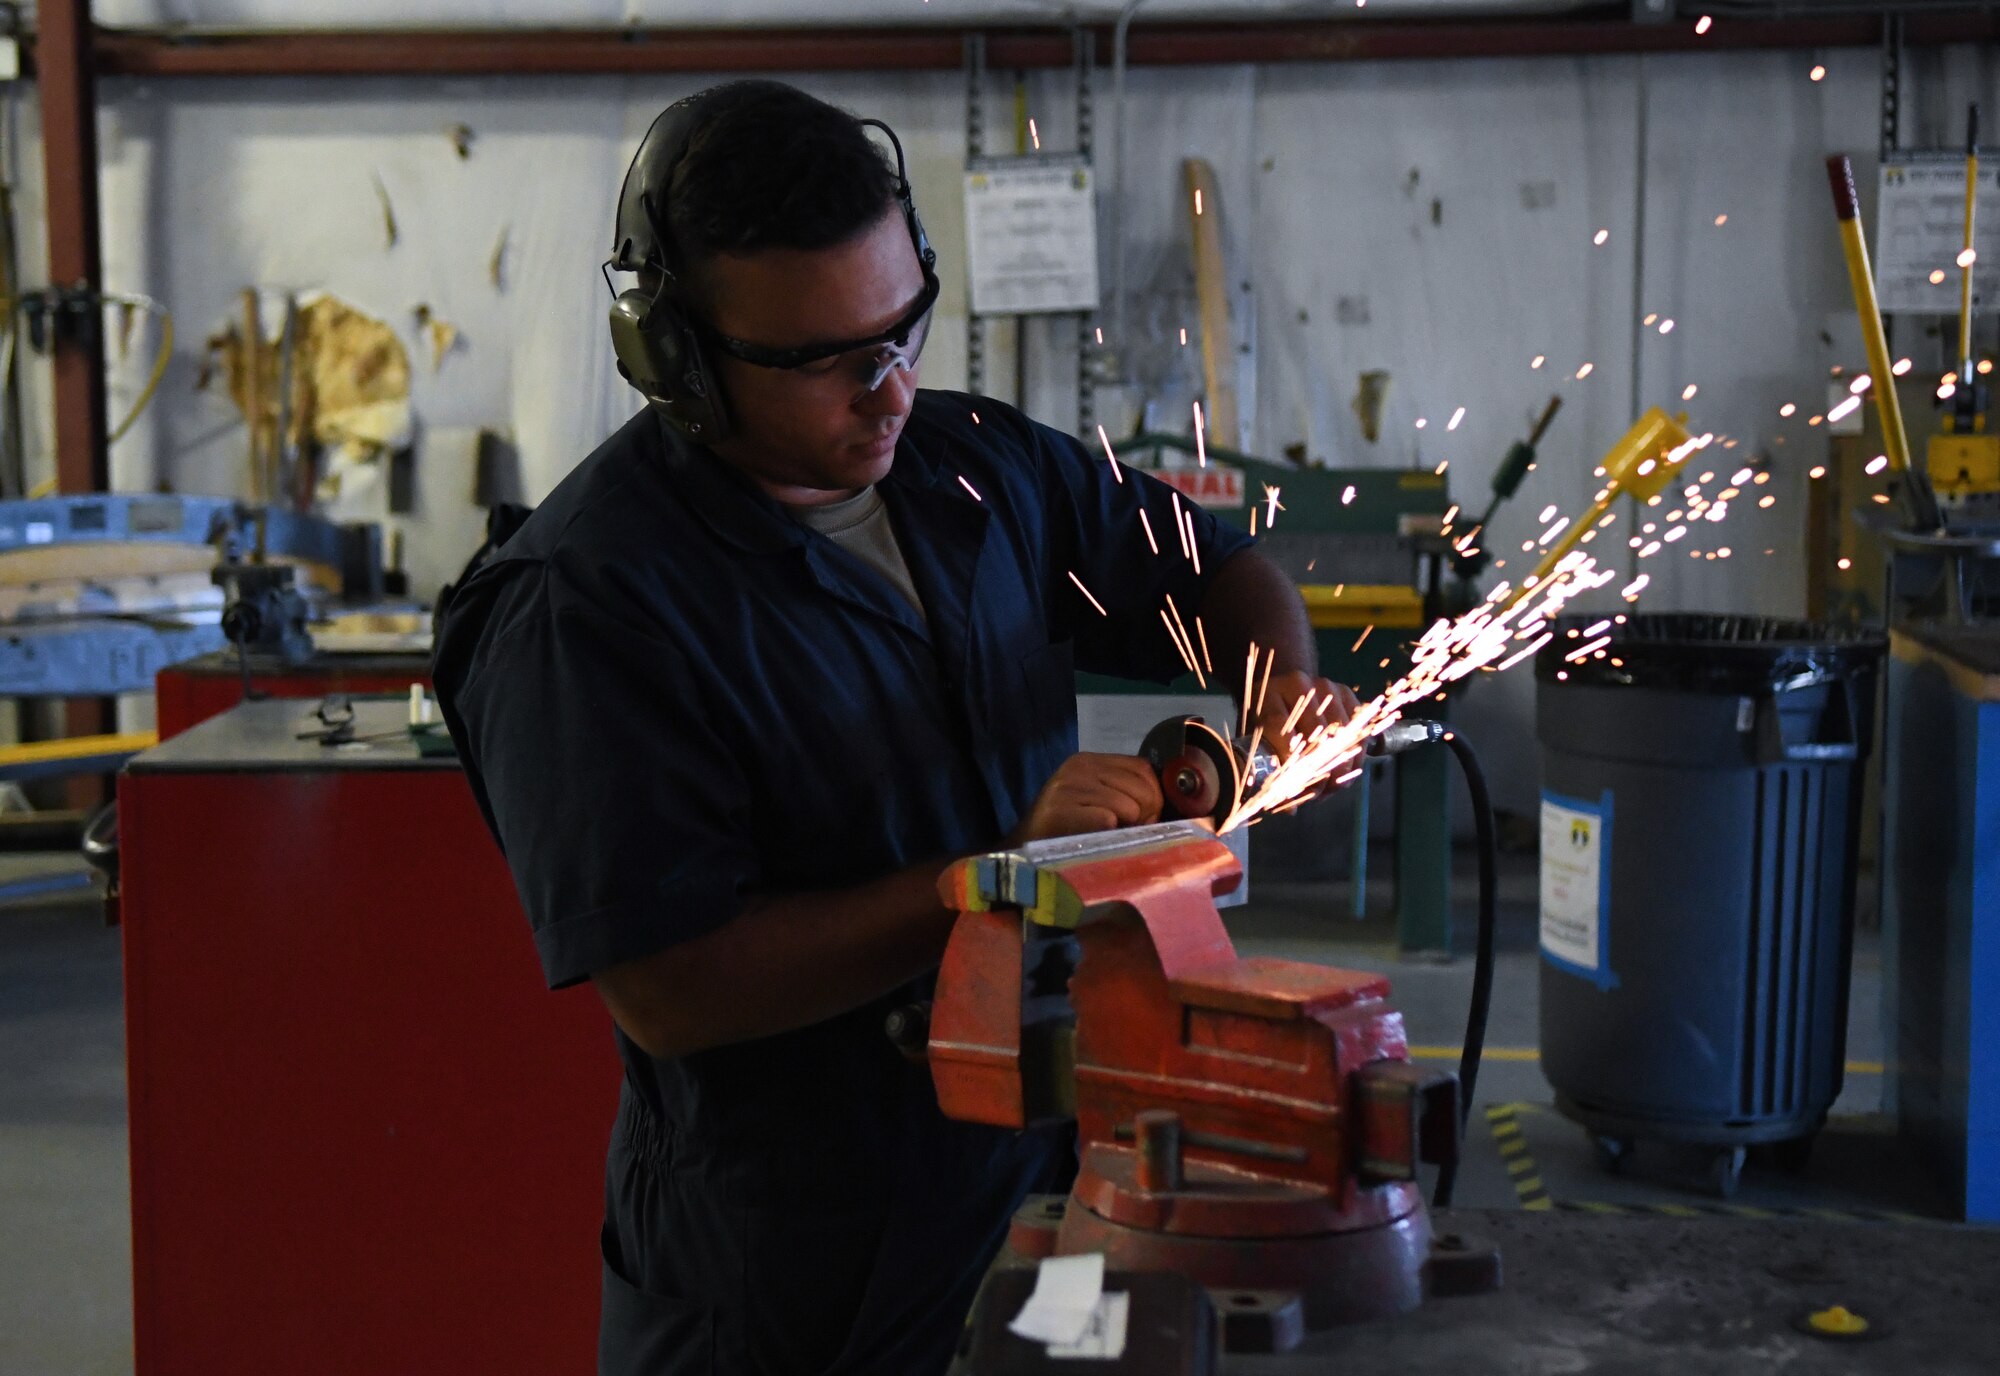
[1104,400,1560,952]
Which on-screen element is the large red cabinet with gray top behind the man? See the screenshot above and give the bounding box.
[118,700,618,1376]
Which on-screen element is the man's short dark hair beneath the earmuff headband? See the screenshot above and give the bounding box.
[666,82,896,306]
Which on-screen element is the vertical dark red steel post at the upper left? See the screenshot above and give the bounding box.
[34,0,110,492]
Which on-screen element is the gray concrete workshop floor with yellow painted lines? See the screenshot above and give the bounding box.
[0,856,1936,1376]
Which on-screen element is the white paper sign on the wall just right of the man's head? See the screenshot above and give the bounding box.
[966,158,1098,316]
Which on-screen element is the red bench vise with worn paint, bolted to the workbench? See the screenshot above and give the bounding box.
[928,820,1480,1328]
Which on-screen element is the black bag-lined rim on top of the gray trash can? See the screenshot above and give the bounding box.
[1534,612,1886,694]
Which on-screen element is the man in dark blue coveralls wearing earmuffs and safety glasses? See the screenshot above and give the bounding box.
[436,82,1352,1376]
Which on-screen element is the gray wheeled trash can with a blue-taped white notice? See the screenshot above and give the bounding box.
[1536,614,1882,1196]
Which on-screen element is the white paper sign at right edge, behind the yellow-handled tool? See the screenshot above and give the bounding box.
[1874,152,2000,316]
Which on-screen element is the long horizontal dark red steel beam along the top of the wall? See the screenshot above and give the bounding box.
[82,12,2000,76]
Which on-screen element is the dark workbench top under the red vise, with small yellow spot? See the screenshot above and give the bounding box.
[974,1210,2000,1376]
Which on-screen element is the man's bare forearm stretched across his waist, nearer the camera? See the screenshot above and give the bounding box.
[596,858,954,1058]
